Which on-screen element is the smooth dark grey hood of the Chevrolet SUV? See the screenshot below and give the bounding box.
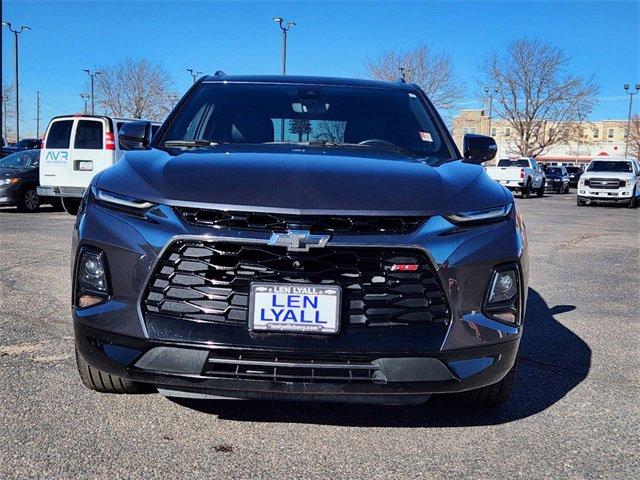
[97,145,511,215]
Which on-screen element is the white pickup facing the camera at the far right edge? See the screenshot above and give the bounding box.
[577,157,640,208]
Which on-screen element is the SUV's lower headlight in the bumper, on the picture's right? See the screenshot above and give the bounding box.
[484,263,521,325]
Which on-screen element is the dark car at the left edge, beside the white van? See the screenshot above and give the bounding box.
[0,150,58,212]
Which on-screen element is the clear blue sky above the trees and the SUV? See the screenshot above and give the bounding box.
[2,0,640,137]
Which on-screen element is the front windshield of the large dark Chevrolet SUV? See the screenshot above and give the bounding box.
[157,82,454,162]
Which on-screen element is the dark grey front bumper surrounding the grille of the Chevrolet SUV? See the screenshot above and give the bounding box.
[73,197,529,403]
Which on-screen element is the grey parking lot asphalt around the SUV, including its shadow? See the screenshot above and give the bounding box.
[0,195,640,479]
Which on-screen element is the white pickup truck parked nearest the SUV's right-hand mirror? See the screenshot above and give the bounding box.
[486,157,546,198]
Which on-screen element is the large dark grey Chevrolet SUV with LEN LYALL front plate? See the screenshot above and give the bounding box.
[72,74,529,405]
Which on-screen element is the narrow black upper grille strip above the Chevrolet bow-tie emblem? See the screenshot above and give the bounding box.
[176,207,426,234]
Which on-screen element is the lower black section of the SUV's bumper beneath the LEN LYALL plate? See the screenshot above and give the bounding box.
[75,323,520,403]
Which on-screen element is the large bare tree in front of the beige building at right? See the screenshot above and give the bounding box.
[482,39,599,157]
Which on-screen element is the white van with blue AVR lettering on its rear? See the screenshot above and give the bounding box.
[38,114,161,215]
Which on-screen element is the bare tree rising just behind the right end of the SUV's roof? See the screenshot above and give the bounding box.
[365,44,463,110]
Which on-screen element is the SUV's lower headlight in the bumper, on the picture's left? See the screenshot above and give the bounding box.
[75,247,109,308]
